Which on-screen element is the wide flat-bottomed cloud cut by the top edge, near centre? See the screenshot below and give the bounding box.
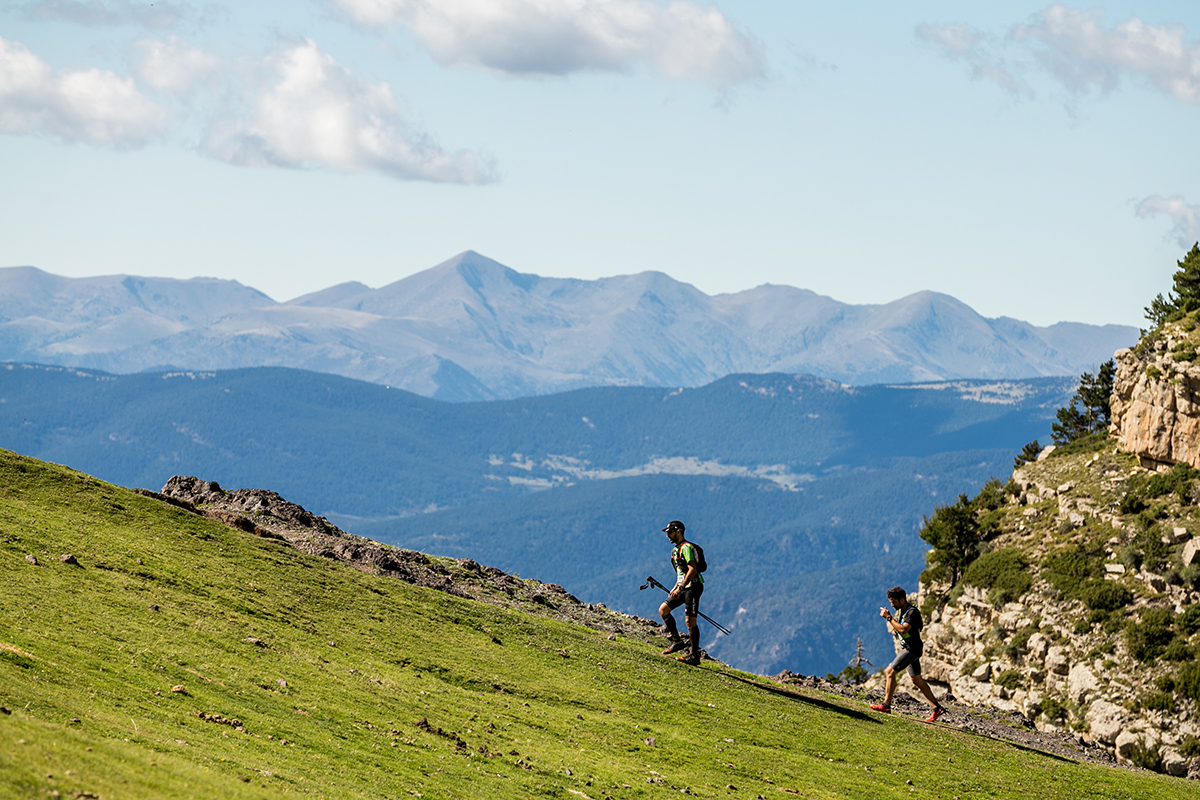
[332,0,762,88]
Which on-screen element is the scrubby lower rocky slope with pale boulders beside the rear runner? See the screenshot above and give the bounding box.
[897,441,1200,776]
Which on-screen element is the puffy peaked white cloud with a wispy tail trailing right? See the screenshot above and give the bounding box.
[206,40,491,184]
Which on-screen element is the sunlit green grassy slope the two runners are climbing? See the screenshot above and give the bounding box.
[0,451,1194,800]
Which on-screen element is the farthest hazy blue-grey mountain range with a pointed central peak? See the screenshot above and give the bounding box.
[0,251,1138,401]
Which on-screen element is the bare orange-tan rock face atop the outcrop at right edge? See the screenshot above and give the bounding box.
[1110,335,1200,468]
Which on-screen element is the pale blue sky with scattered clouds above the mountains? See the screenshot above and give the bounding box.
[0,0,1200,326]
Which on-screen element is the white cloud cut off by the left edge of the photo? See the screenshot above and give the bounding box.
[0,38,166,148]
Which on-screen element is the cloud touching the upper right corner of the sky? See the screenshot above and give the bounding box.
[1013,4,1200,104]
